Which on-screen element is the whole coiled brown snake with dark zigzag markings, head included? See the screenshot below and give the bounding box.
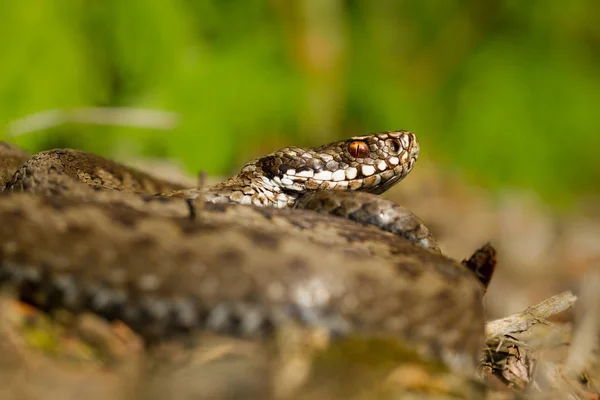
[0,131,484,373]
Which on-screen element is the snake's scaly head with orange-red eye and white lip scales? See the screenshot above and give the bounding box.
[243,131,419,193]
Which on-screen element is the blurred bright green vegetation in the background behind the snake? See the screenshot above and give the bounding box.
[0,0,600,204]
